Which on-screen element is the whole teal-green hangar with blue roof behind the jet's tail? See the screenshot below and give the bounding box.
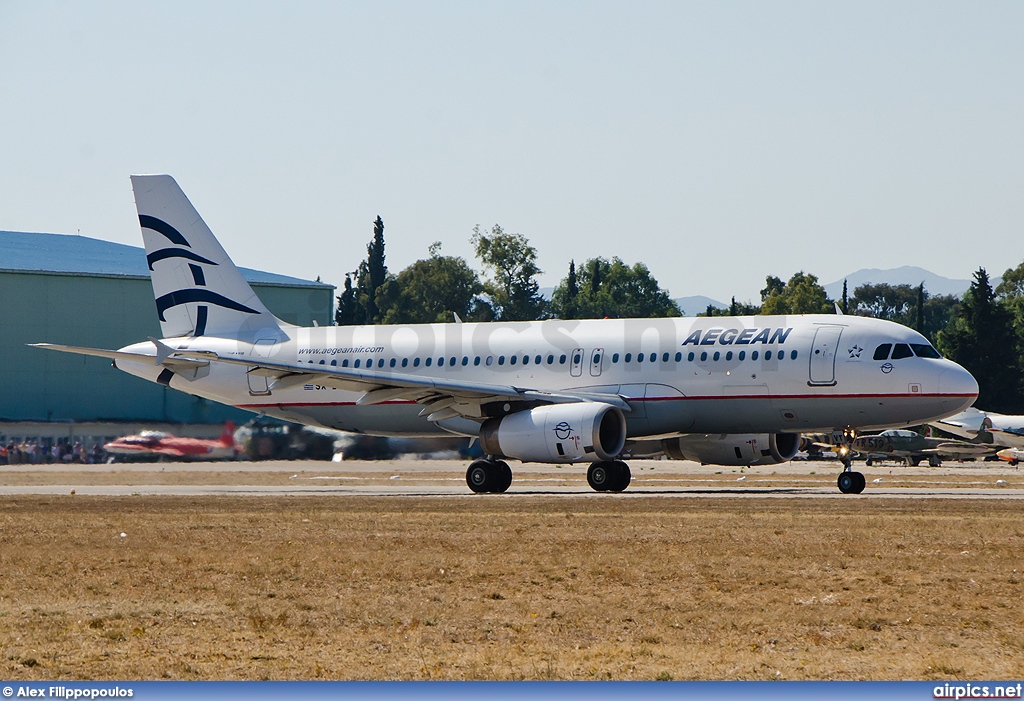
[0,231,335,436]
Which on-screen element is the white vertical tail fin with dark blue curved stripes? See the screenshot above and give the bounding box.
[131,175,283,339]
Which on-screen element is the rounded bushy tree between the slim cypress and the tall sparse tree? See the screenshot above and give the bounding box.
[378,243,488,323]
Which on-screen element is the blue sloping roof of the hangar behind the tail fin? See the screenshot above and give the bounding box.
[0,231,334,289]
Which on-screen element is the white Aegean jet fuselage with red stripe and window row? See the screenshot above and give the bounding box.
[117,315,977,438]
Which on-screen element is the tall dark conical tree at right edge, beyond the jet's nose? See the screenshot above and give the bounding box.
[938,268,1024,413]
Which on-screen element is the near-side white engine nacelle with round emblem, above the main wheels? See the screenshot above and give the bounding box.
[480,401,626,463]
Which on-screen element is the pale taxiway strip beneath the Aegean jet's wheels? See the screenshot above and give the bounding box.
[0,458,1024,499]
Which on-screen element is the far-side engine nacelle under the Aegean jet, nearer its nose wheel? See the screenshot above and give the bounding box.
[662,433,800,467]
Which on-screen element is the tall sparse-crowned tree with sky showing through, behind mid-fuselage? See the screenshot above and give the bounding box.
[471,224,547,321]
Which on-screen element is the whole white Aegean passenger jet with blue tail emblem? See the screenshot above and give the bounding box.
[29,175,978,493]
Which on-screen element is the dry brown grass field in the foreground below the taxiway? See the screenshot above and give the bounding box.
[0,495,1024,680]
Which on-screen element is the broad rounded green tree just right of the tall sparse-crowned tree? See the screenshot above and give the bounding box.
[551,258,681,319]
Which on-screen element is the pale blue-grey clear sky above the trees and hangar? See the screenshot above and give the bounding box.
[0,0,1024,301]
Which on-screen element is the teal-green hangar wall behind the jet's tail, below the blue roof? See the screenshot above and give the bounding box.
[0,236,334,424]
